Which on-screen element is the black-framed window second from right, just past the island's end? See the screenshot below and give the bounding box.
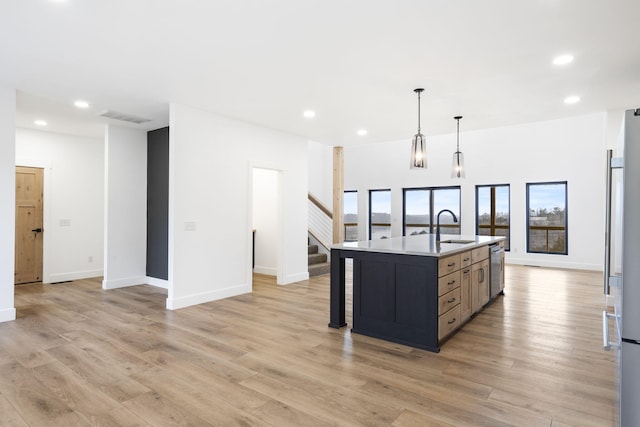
[476,184,511,250]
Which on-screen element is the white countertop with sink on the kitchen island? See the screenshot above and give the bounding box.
[331,234,506,257]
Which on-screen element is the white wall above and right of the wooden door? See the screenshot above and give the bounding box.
[16,128,104,283]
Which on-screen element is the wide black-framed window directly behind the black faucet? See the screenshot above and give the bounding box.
[403,187,460,236]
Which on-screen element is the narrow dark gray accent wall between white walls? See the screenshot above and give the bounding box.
[147,127,169,280]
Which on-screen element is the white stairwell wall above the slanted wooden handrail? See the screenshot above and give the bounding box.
[308,141,333,209]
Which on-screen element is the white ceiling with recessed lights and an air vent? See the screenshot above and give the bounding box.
[0,0,640,145]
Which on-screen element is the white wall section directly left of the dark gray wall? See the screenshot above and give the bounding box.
[102,125,147,289]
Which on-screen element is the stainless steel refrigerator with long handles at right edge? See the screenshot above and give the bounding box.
[602,109,640,427]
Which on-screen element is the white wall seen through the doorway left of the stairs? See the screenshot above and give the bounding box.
[253,168,280,276]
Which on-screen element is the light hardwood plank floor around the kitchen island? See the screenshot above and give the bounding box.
[0,266,617,427]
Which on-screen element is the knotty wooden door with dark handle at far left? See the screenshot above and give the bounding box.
[14,166,43,285]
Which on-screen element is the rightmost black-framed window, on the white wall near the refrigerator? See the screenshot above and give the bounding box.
[527,181,568,255]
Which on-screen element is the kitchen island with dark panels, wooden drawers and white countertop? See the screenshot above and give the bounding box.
[329,234,505,352]
